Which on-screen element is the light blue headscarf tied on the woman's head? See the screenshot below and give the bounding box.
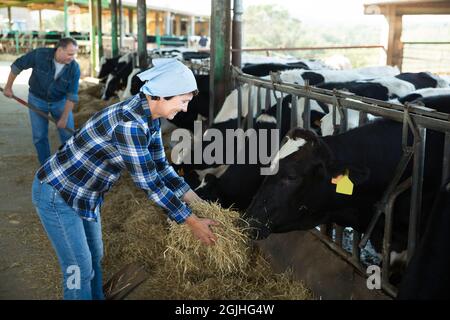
[137,58,197,97]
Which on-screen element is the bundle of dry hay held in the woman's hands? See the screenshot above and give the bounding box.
[164,201,250,276]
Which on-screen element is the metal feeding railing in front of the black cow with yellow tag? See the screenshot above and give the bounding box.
[232,67,450,297]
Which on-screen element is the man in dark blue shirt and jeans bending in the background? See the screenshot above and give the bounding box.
[4,38,80,165]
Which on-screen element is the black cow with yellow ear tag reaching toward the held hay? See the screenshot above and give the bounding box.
[246,115,443,252]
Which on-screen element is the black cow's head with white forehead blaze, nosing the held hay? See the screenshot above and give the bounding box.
[245,128,369,239]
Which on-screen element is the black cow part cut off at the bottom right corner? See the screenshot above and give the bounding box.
[397,181,450,300]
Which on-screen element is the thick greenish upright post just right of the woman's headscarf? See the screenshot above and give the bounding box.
[209,0,231,124]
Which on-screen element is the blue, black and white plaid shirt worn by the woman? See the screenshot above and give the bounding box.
[37,94,192,223]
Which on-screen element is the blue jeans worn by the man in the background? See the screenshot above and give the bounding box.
[28,92,74,165]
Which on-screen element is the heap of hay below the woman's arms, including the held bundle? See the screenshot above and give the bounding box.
[102,176,312,300]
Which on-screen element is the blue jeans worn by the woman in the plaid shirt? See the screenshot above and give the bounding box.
[32,177,104,300]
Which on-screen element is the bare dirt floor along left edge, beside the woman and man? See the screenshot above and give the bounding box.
[0,56,60,299]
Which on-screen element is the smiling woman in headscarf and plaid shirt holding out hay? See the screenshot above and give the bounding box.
[27,59,217,299]
